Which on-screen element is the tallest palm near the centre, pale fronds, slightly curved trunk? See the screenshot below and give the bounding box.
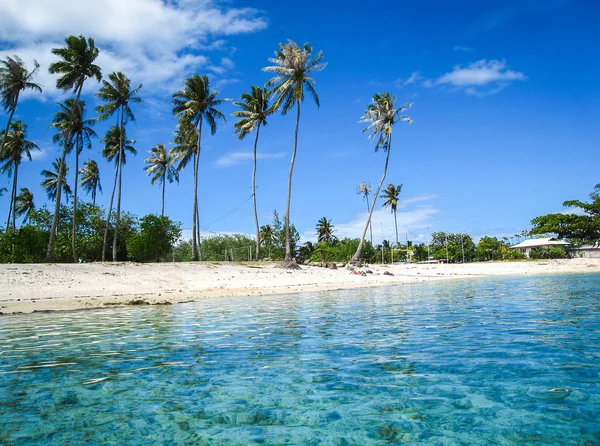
[263,40,327,268]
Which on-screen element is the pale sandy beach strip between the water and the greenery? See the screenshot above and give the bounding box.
[0,259,600,314]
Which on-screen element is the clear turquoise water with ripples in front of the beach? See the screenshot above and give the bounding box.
[0,275,600,445]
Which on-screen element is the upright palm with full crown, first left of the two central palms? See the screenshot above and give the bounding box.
[172,74,227,260]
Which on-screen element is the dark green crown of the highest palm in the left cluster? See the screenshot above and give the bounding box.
[48,36,102,101]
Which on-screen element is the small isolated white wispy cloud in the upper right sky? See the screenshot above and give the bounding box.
[432,60,526,96]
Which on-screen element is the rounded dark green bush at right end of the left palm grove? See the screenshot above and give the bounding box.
[127,214,181,262]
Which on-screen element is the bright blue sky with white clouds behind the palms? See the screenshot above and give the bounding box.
[0,0,600,241]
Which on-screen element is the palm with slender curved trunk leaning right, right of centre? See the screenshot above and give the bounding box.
[350,92,413,264]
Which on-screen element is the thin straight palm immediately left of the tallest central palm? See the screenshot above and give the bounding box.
[233,87,273,260]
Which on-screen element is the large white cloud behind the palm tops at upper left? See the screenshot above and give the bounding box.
[0,0,267,97]
